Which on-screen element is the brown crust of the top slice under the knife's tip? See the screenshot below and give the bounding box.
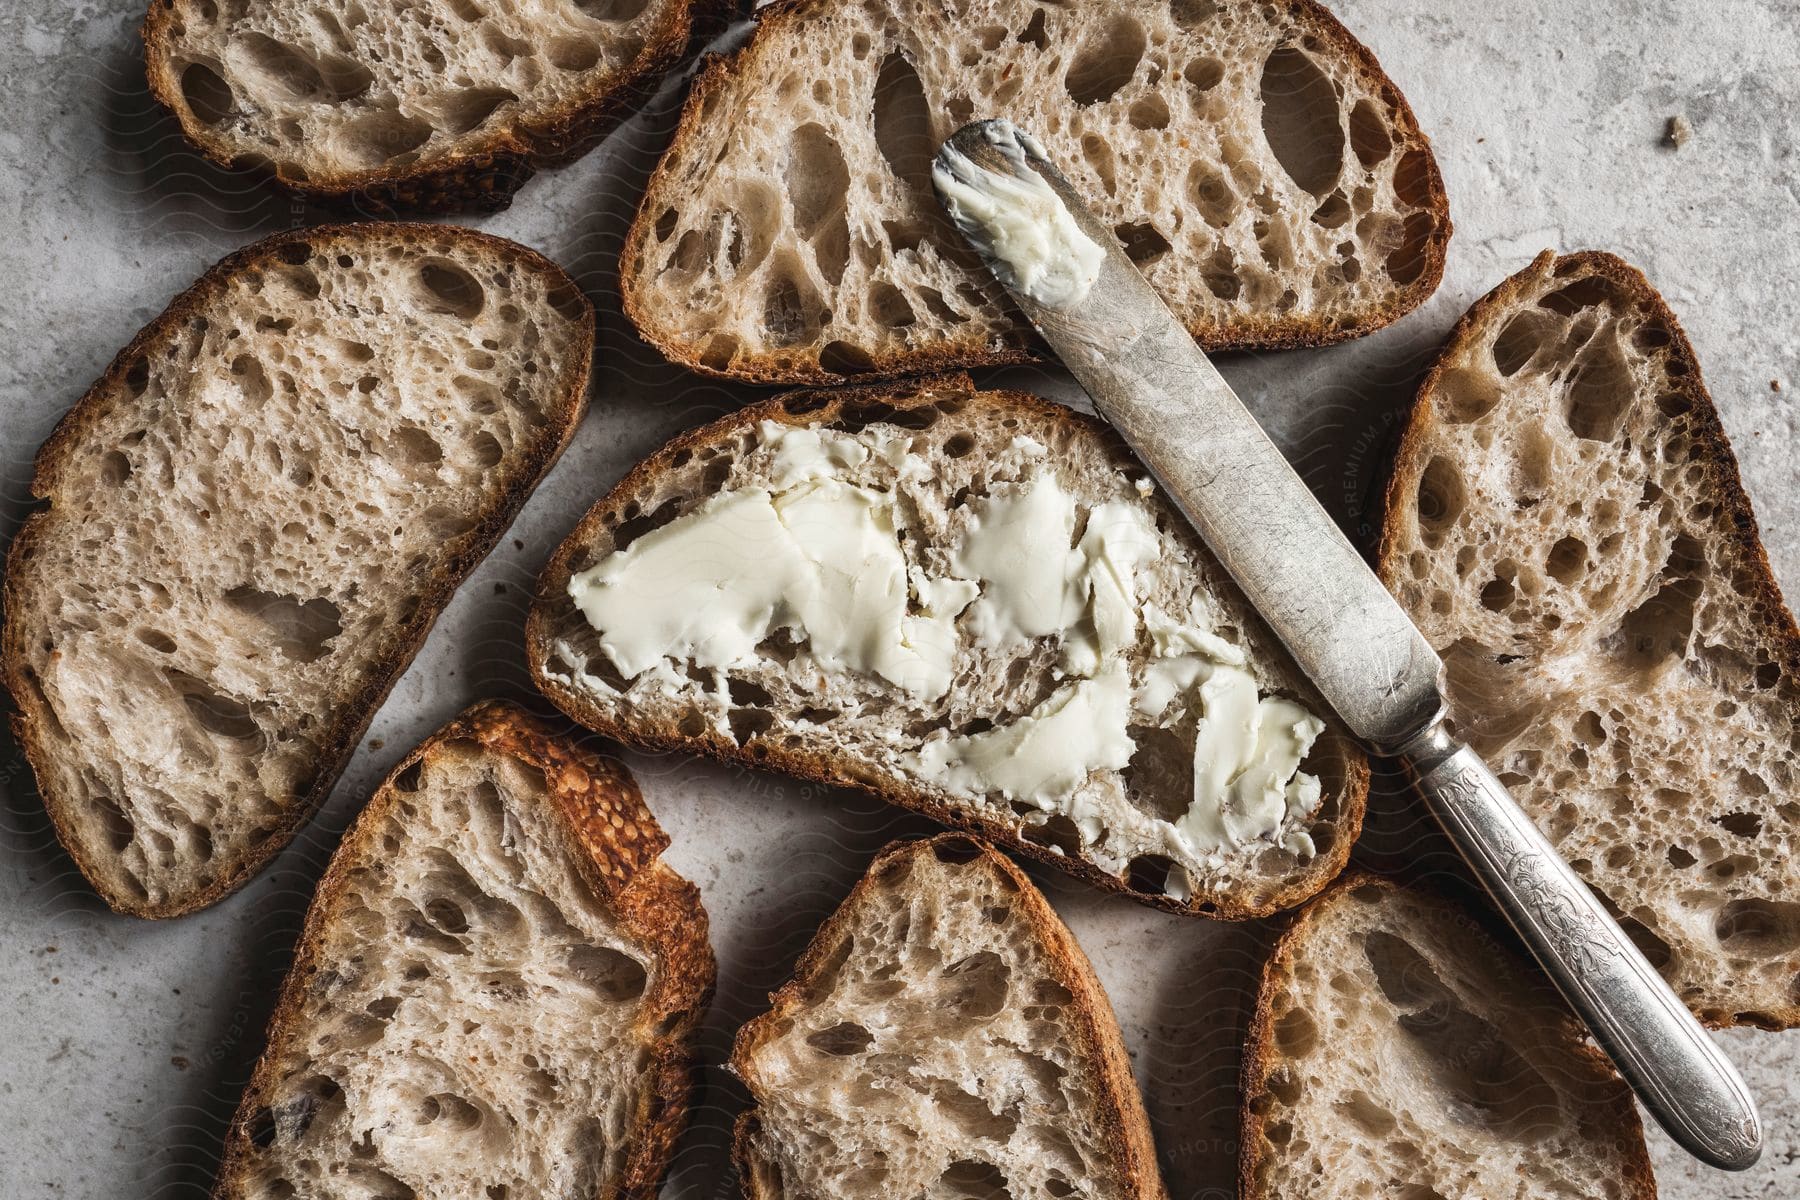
[619,0,1453,385]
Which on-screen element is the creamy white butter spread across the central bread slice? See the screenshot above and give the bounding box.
[569,421,1325,881]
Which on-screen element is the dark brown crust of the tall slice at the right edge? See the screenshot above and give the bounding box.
[1377,250,1800,1031]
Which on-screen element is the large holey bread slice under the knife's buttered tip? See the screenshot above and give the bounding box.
[619,0,1451,381]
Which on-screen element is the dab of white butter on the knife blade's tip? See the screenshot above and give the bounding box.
[931,121,1107,308]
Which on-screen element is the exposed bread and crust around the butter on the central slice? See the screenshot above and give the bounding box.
[526,376,1368,918]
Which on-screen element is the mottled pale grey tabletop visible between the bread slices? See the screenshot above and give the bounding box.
[0,0,1800,1200]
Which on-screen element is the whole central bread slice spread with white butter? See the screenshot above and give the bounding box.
[526,378,1368,918]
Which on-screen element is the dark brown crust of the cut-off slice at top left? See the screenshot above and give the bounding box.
[142,0,736,214]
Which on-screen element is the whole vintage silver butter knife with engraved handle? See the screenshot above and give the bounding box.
[932,121,1762,1171]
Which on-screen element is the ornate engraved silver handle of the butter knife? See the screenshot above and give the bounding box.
[1400,723,1762,1171]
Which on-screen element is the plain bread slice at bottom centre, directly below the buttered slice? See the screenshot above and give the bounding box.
[731,835,1166,1200]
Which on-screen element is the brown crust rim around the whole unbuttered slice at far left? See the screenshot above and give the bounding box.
[0,221,594,918]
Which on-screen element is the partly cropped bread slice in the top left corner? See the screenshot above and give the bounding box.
[144,0,727,212]
